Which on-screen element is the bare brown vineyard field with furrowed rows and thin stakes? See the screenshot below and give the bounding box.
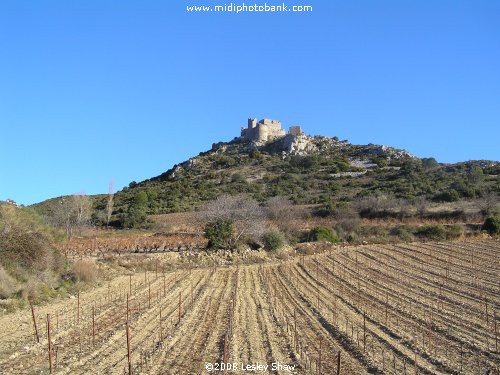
[0,240,500,374]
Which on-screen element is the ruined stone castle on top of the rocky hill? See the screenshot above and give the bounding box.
[241,118,303,144]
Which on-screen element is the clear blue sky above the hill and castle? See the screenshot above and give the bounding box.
[0,0,500,204]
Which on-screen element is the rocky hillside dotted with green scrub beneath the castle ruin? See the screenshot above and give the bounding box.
[35,128,500,225]
